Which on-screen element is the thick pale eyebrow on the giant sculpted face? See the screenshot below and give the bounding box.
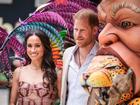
[112,2,140,17]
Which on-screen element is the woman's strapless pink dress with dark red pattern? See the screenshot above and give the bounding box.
[17,81,57,105]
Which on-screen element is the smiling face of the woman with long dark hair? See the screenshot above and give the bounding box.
[27,35,44,61]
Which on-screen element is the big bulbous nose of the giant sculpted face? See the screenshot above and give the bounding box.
[98,23,119,46]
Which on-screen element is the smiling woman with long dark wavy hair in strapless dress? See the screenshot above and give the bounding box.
[10,30,57,105]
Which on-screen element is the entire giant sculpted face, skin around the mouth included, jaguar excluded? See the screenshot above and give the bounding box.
[94,0,140,94]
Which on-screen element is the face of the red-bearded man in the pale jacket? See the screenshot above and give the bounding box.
[74,19,95,47]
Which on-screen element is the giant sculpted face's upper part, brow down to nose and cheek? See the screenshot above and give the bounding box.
[98,0,140,56]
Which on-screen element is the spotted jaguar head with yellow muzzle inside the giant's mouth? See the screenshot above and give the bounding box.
[81,47,128,90]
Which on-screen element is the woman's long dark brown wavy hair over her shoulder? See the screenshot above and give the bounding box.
[24,30,57,86]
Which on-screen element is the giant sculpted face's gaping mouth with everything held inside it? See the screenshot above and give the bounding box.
[81,47,132,105]
